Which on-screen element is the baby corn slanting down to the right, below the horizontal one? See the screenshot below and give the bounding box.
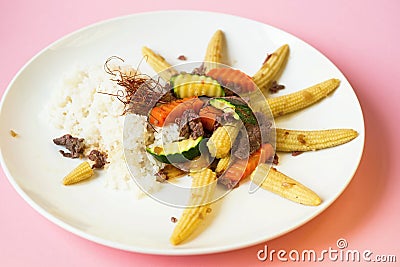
[250,163,322,206]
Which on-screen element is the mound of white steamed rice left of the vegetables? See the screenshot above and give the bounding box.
[46,66,163,195]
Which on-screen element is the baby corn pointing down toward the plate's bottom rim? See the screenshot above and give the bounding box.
[170,169,217,245]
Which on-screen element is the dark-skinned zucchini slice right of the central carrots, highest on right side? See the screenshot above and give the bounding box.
[210,97,257,124]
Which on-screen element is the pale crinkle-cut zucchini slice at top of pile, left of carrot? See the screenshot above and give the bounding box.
[170,73,225,98]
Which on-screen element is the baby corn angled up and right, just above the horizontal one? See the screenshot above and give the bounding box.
[267,79,340,118]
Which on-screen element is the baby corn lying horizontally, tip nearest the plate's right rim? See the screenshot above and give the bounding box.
[276,129,358,152]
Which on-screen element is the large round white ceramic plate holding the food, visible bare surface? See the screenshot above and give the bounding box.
[0,11,364,255]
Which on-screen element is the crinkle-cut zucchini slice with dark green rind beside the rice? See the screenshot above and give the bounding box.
[146,136,203,163]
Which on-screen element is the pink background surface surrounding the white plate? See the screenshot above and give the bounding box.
[0,0,400,267]
